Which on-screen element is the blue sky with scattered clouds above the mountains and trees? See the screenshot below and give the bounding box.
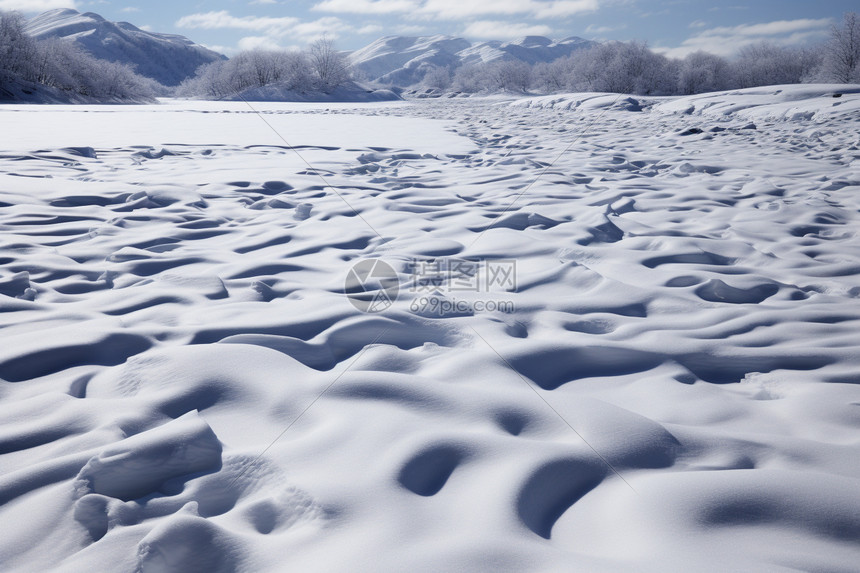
[0,0,858,56]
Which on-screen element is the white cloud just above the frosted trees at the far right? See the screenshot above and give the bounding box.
[655,18,832,58]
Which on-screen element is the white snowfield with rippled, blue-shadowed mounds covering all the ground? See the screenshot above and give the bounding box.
[0,86,860,572]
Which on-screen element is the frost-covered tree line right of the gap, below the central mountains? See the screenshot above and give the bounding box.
[421,13,860,95]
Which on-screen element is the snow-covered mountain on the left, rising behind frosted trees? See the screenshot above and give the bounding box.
[26,9,224,86]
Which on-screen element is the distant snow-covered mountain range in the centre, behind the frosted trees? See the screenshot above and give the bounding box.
[349,36,594,86]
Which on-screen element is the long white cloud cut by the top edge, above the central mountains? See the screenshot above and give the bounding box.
[312,0,600,20]
